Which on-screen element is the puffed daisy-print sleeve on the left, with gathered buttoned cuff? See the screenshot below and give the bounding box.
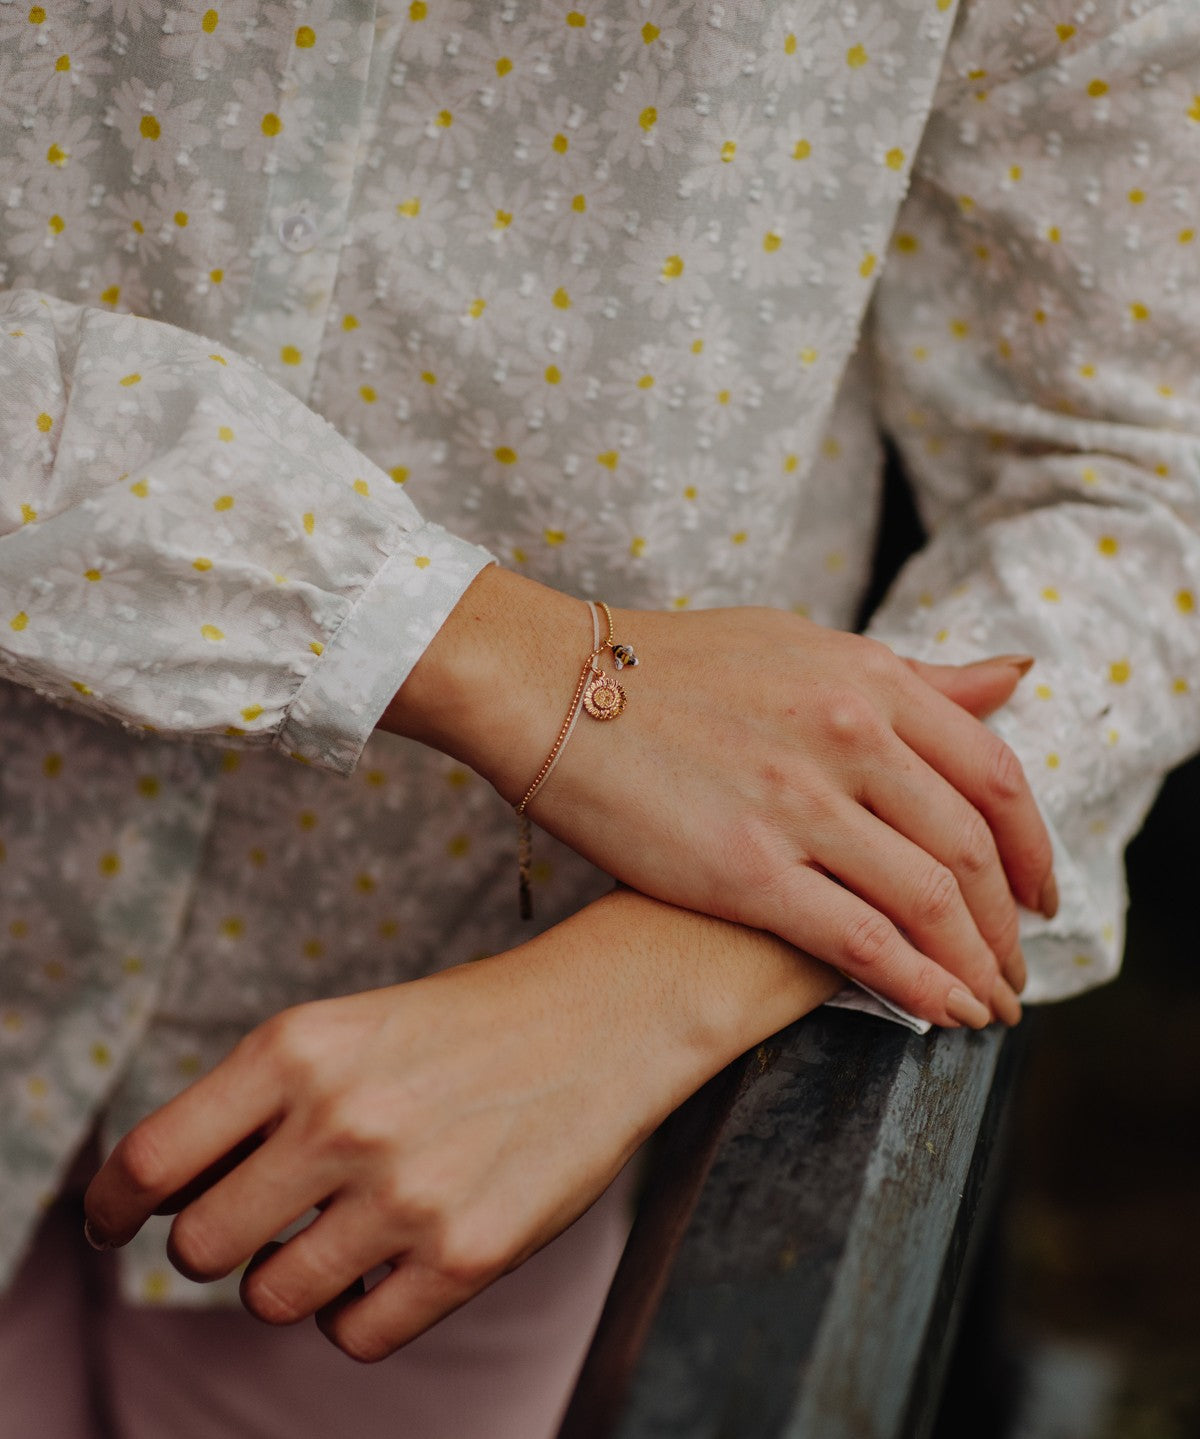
[0,291,491,773]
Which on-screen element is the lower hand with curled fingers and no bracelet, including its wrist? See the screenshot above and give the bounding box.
[85,892,839,1360]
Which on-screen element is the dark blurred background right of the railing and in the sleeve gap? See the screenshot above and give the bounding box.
[865,458,1200,1439]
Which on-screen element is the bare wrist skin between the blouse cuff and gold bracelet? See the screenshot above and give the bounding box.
[380,566,591,803]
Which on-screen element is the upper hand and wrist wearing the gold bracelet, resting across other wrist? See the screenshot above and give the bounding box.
[383,568,1058,1026]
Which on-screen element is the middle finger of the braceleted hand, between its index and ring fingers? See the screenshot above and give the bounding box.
[862,744,1026,997]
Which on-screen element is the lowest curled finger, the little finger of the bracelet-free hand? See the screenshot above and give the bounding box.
[317,1256,495,1364]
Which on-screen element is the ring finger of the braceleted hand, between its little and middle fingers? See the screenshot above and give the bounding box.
[813,803,1020,1025]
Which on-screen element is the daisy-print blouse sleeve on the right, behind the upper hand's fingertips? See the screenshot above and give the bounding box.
[871,0,1200,1000]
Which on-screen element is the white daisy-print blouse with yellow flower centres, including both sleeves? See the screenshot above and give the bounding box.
[0,0,1200,1302]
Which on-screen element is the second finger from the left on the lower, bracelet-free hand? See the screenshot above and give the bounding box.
[167,1120,343,1284]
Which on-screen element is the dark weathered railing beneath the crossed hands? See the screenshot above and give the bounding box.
[561,1010,1014,1439]
